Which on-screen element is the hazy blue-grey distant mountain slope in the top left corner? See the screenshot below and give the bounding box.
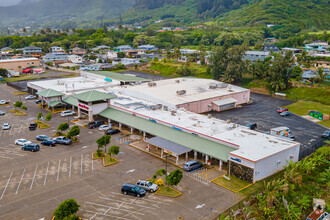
[0,0,135,26]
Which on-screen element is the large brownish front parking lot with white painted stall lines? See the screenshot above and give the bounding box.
[0,84,241,220]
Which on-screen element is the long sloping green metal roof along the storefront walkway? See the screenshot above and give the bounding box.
[100,108,236,162]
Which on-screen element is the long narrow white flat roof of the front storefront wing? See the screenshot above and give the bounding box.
[111,92,299,161]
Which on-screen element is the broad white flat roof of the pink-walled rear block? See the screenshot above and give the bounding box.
[122,77,248,107]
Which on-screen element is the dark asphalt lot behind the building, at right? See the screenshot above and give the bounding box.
[212,93,326,159]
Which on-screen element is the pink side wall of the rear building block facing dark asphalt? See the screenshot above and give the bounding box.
[177,90,250,113]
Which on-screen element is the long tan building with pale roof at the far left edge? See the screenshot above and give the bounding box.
[0,58,40,72]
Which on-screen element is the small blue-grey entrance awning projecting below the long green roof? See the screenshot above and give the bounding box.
[146,137,191,156]
